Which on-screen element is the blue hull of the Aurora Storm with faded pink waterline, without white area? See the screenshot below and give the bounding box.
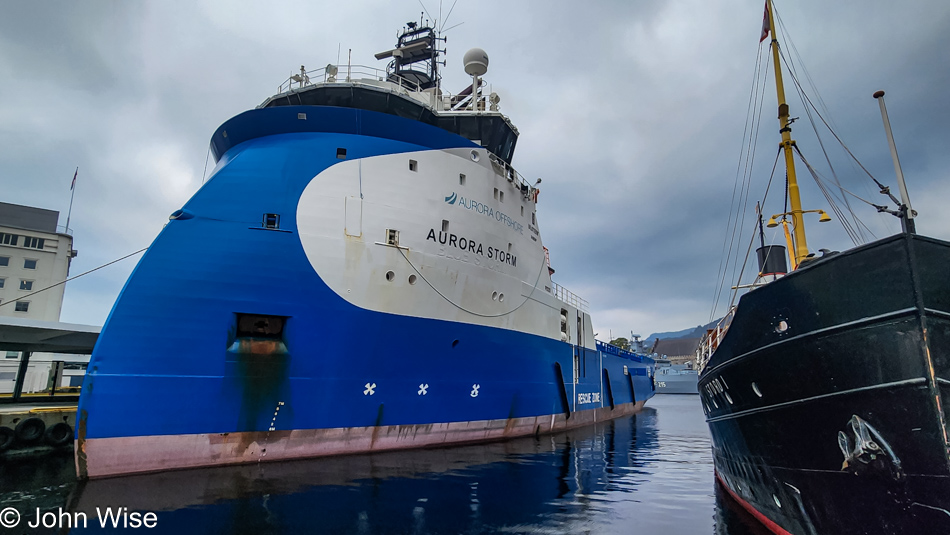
[76,106,654,477]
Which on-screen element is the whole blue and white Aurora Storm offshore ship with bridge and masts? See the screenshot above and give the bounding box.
[76,23,654,478]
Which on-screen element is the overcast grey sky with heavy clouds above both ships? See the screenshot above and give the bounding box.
[0,0,950,339]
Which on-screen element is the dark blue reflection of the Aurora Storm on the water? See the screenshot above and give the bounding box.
[70,408,658,533]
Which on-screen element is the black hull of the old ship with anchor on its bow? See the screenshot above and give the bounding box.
[699,234,950,535]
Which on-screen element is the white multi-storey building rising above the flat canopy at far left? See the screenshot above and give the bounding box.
[0,202,77,321]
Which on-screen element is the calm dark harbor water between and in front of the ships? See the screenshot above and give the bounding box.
[0,395,765,535]
